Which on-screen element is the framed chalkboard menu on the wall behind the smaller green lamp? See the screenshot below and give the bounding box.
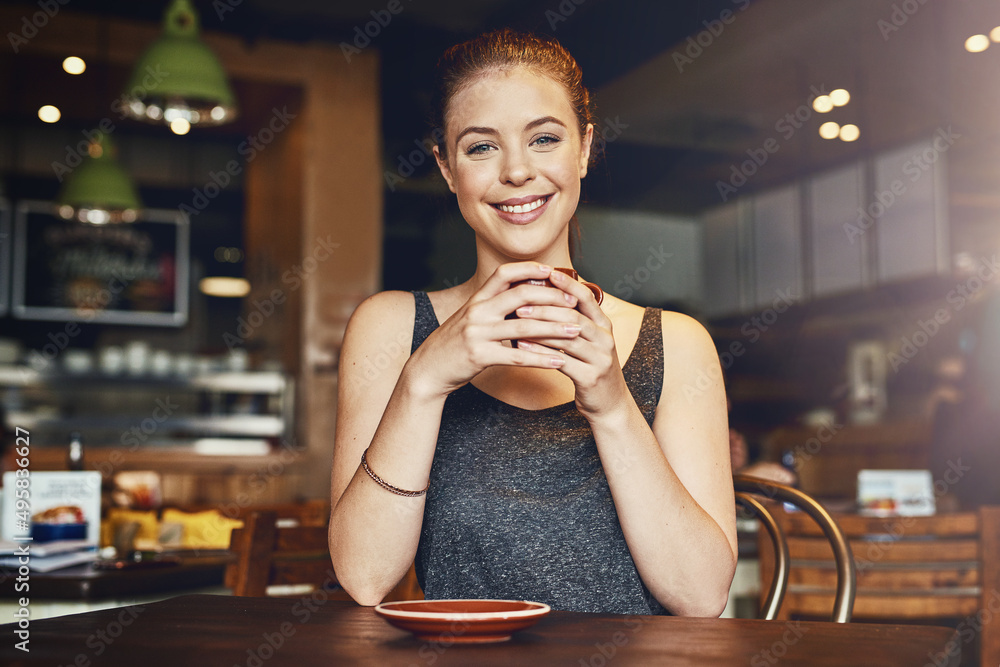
[12,201,189,326]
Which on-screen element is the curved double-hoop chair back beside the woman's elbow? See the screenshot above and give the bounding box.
[733,475,857,623]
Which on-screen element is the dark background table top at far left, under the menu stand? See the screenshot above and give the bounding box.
[0,555,231,604]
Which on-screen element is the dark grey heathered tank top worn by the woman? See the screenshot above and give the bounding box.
[411,292,667,614]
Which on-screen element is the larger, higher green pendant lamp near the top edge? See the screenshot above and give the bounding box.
[123,0,237,134]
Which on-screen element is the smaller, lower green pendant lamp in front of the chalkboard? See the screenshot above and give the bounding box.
[56,134,142,225]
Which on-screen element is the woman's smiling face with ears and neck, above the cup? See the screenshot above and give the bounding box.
[435,68,593,266]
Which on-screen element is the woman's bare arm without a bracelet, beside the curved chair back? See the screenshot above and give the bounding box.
[591,313,737,616]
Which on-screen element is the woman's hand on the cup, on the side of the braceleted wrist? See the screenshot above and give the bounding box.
[407,262,580,395]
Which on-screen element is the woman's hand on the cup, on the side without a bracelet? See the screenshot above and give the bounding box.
[517,271,631,419]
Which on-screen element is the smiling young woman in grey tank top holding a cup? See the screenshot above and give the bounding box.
[330,30,736,616]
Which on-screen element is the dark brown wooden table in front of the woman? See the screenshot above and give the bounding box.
[0,591,959,667]
